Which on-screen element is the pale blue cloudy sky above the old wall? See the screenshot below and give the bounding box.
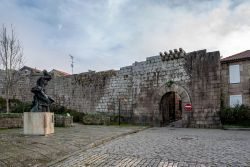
[0,0,250,73]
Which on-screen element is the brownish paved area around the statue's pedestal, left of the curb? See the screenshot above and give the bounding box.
[0,124,142,167]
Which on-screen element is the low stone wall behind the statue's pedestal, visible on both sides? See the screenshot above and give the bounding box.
[0,113,73,128]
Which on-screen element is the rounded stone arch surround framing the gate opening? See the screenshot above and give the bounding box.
[154,84,192,126]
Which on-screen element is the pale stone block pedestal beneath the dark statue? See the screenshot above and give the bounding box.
[23,112,54,135]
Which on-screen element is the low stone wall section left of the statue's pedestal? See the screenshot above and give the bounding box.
[0,113,23,128]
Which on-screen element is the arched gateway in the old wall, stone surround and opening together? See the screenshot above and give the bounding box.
[154,84,191,126]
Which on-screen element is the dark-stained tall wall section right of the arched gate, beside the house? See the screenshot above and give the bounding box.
[185,50,221,128]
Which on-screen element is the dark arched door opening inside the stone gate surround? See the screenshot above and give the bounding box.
[160,92,182,126]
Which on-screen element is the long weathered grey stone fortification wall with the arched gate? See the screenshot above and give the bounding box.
[0,49,220,127]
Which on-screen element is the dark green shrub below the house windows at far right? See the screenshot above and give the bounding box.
[220,105,250,125]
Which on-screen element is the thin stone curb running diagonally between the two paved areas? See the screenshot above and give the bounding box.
[45,127,151,167]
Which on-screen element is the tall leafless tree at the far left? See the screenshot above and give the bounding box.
[0,25,23,113]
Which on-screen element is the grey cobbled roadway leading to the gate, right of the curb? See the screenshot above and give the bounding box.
[52,128,250,167]
